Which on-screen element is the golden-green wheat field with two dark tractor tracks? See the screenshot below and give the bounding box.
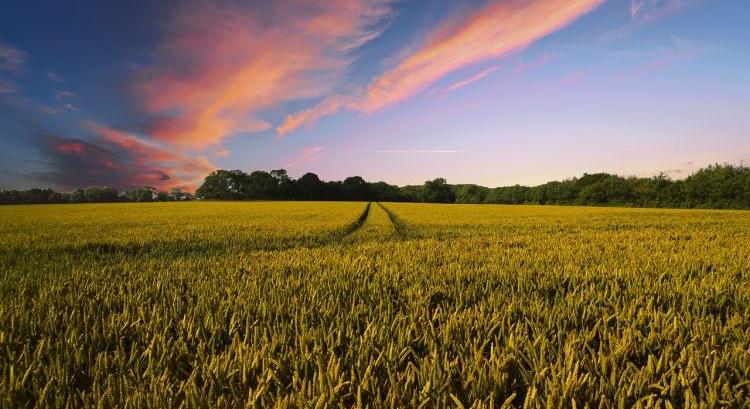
[0,202,750,408]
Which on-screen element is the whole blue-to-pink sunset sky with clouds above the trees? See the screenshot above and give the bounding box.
[0,0,750,190]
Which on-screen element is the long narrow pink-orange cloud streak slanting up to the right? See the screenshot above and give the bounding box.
[277,0,604,136]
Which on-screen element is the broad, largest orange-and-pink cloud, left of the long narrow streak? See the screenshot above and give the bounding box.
[137,0,391,148]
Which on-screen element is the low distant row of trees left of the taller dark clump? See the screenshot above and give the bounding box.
[0,186,194,204]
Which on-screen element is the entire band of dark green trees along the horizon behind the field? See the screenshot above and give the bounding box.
[0,164,750,209]
